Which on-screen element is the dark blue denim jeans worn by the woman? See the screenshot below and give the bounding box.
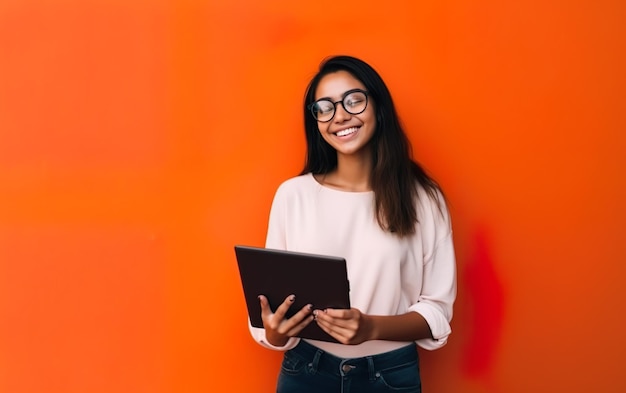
[276,340,422,393]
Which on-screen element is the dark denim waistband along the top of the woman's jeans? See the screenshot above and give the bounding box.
[291,340,418,378]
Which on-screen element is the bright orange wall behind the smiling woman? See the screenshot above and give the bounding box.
[0,0,626,393]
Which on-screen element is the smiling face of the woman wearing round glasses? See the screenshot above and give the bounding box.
[315,71,376,155]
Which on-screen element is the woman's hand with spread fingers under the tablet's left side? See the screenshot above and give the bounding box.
[259,295,314,347]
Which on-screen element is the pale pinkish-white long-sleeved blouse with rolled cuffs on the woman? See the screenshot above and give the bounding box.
[250,174,456,358]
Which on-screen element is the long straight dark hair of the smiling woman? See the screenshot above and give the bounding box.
[300,56,443,237]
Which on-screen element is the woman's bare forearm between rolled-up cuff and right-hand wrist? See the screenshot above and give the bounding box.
[365,312,433,341]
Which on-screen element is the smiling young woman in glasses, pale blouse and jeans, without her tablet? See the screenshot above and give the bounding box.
[250,56,456,393]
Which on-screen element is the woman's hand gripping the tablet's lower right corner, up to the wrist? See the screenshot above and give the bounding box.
[313,308,374,345]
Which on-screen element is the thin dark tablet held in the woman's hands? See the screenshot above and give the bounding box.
[235,245,350,342]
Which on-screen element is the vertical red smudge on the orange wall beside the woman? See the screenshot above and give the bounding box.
[461,228,504,379]
